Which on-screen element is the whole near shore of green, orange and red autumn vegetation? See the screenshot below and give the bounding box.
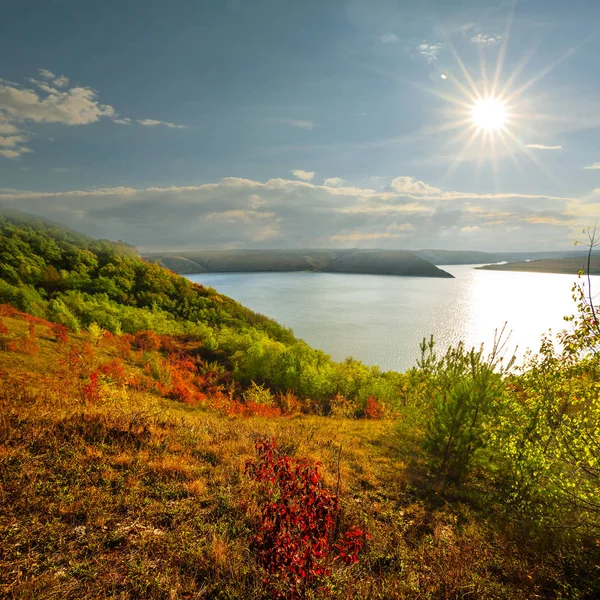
[0,212,600,599]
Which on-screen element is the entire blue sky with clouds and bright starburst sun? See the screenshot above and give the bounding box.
[0,0,600,251]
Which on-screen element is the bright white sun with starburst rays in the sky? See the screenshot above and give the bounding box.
[418,5,585,183]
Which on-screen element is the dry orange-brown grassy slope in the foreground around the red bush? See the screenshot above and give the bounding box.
[0,318,592,599]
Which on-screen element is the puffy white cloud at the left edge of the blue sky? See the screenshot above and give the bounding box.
[0,69,186,158]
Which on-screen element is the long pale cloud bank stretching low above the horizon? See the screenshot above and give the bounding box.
[0,176,590,250]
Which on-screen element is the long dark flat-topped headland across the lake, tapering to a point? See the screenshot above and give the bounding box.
[144,249,452,277]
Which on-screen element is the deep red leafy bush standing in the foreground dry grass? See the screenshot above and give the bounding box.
[246,440,370,599]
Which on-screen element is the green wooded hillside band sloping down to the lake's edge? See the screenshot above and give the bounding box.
[0,212,402,412]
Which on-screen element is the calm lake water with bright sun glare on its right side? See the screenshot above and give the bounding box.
[189,265,600,371]
